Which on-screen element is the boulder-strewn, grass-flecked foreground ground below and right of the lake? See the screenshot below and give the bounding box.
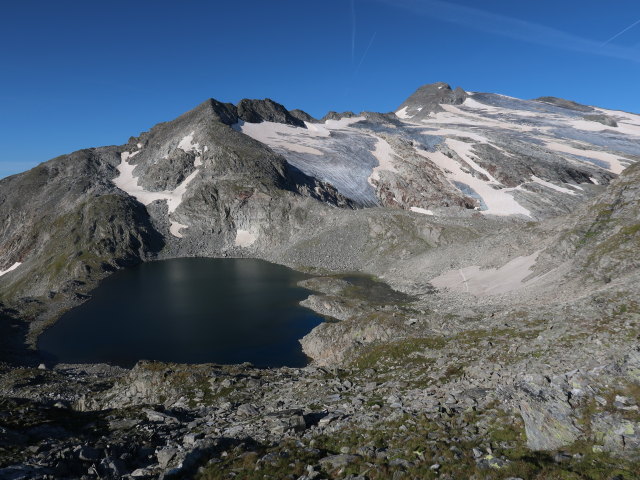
[0,253,640,479]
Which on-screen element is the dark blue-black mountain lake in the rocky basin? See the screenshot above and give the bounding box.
[38,258,322,367]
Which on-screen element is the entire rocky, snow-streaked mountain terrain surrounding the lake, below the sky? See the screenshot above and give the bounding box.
[0,83,640,479]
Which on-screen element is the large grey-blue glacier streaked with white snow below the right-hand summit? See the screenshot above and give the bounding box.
[234,93,640,218]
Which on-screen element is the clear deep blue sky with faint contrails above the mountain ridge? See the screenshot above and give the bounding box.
[0,0,640,177]
